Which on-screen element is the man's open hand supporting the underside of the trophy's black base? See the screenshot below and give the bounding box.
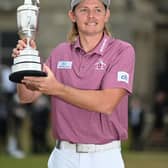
[22,64,64,96]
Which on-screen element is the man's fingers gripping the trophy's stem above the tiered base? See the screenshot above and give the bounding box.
[12,39,36,58]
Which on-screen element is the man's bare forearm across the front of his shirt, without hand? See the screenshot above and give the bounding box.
[56,86,126,114]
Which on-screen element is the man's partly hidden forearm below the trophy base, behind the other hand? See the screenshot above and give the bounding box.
[17,84,40,103]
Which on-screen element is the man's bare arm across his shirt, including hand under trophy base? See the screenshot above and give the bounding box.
[23,66,127,114]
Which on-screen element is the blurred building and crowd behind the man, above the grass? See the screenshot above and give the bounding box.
[0,0,168,158]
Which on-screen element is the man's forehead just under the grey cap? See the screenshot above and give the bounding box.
[77,0,104,7]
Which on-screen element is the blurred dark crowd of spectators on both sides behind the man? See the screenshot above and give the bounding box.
[0,65,168,158]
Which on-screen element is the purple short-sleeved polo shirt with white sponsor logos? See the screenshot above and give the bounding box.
[47,35,135,144]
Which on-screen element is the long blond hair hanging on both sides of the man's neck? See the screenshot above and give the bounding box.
[67,23,111,43]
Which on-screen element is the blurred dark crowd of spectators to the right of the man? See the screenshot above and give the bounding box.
[129,58,168,150]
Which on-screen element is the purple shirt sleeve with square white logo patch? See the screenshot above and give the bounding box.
[102,45,135,93]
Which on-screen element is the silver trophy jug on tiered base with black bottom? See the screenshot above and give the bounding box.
[9,0,46,83]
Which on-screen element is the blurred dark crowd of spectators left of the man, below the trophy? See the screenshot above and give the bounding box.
[0,65,51,158]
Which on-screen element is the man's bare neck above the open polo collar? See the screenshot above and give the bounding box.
[80,33,103,52]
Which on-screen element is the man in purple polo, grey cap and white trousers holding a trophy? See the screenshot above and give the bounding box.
[13,0,134,168]
